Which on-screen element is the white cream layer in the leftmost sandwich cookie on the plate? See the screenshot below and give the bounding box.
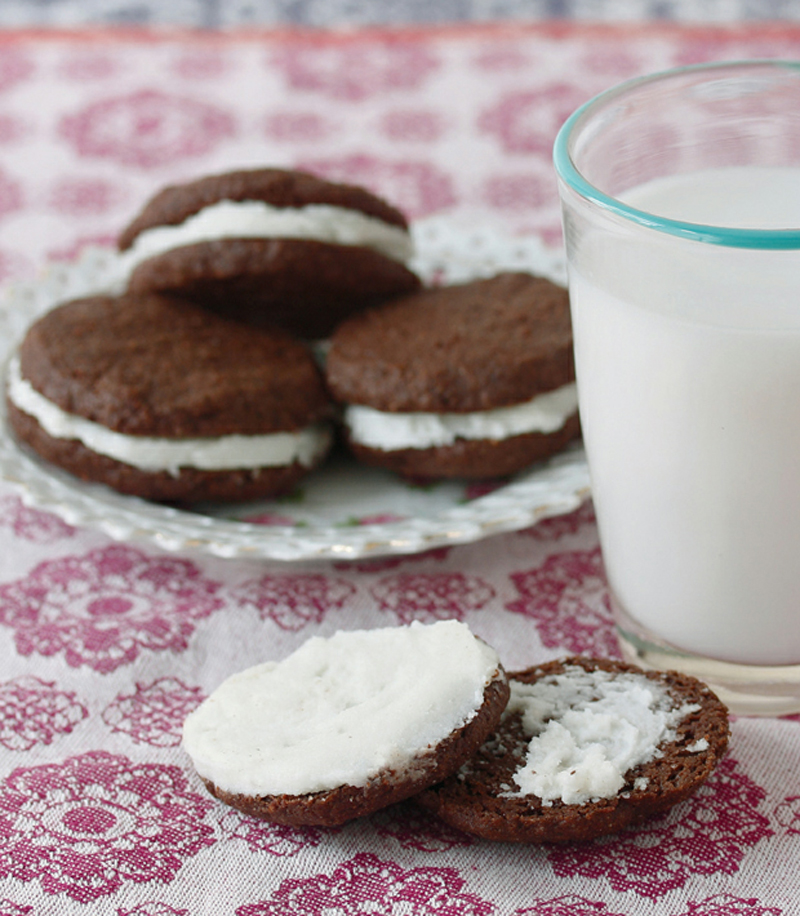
[7,356,331,474]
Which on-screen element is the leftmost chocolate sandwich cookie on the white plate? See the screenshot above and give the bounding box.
[7,295,331,502]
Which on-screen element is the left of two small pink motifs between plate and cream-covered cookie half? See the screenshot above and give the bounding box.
[233,574,356,630]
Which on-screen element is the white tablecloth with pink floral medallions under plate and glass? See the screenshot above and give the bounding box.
[0,24,800,916]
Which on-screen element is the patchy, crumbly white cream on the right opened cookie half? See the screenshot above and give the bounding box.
[504,666,707,805]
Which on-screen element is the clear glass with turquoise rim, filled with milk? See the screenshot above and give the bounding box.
[555,61,800,715]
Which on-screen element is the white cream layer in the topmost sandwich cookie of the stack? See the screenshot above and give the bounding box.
[122,200,413,270]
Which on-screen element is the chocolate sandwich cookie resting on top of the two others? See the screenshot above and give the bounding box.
[119,169,420,339]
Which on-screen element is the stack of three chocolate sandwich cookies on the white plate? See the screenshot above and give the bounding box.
[7,169,579,502]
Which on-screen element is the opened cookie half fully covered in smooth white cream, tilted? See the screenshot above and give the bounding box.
[183,620,508,826]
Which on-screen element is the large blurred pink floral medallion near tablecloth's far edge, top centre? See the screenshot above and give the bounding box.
[271,41,438,102]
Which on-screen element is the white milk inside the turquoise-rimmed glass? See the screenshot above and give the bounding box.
[570,168,800,665]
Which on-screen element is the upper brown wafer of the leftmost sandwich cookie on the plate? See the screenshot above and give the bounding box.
[20,295,329,438]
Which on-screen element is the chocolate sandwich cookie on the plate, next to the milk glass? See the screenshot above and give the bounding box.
[326,273,580,478]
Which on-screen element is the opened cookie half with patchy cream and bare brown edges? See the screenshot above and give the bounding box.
[417,658,728,843]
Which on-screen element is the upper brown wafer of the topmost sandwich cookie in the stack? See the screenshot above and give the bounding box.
[118,169,408,251]
